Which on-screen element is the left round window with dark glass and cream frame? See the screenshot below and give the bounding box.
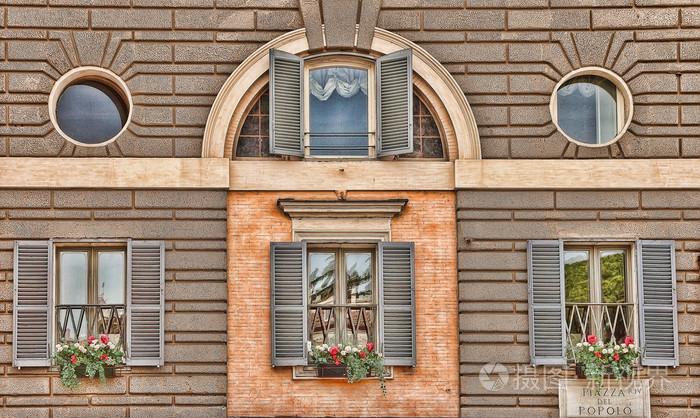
[50,67,131,146]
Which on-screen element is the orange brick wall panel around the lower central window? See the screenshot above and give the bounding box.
[228,192,459,416]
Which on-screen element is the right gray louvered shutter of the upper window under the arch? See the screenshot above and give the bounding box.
[377,49,413,157]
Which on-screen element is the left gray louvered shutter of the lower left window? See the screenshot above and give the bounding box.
[12,241,53,367]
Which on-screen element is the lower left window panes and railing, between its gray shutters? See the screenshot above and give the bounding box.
[55,245,127,344]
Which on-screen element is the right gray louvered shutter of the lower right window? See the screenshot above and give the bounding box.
[637,241,678,367]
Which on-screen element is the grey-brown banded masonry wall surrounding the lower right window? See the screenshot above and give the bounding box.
[457,190,700,417]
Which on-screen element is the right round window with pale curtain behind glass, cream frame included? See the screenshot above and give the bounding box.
[550,68,632,147]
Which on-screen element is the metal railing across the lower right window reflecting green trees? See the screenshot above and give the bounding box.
[565,303,636,360]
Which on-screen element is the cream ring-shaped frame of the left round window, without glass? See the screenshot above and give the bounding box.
[49,66,134,148]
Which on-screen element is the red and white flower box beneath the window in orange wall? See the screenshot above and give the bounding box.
[308,342,386,395]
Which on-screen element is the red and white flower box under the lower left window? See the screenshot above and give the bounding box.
[52,334,124,390]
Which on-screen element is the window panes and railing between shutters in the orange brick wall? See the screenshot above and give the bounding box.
[307,246,377,346]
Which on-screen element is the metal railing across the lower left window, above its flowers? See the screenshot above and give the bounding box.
[56,304,126,347]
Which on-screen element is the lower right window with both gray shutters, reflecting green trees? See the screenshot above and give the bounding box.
[528,240,679,367]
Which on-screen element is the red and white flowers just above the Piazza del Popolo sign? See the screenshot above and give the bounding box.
[571,334,641,388]
